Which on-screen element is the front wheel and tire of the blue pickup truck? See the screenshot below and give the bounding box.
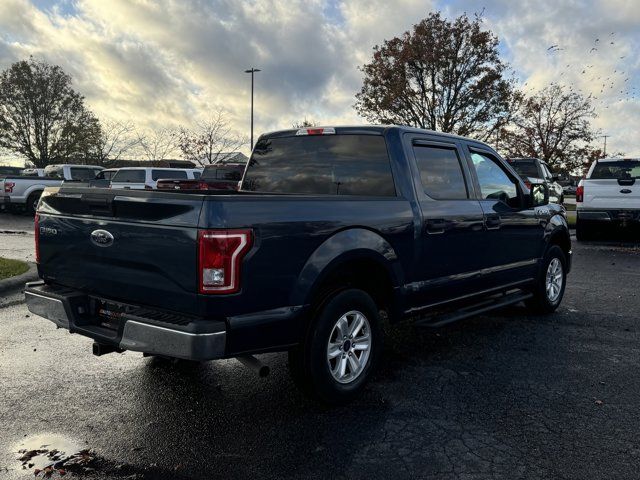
[525,245,567,314]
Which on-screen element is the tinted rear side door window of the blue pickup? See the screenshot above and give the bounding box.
[413,145,469,200]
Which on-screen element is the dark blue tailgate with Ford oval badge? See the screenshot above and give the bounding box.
[38,188,202,314]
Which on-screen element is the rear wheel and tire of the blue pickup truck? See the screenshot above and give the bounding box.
[289,289,383,405]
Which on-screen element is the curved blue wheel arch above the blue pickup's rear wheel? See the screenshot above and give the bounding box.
[291,227,403,305]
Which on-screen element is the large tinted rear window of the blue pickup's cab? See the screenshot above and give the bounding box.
[242,135,395,196]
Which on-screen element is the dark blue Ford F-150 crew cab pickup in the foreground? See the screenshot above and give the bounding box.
[25,126,571,403]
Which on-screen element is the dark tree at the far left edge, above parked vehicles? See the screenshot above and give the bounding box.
[0,58,101,168]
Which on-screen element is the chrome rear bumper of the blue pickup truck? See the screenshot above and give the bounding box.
[24,281,226,360]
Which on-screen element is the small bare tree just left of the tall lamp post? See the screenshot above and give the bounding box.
[177,110,248,166]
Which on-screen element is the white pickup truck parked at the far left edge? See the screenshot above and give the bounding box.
[0,164,102,214]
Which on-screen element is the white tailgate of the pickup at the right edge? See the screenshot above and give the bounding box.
[583,179,640,210]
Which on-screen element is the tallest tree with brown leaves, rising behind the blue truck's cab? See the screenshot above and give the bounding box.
[354,12,514,140]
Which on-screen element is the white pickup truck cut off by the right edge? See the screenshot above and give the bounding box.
[576,158,640,240]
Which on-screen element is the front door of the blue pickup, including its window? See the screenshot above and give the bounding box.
[465,146,544,286]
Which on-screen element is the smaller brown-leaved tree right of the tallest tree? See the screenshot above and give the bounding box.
[500,84,598,173]
